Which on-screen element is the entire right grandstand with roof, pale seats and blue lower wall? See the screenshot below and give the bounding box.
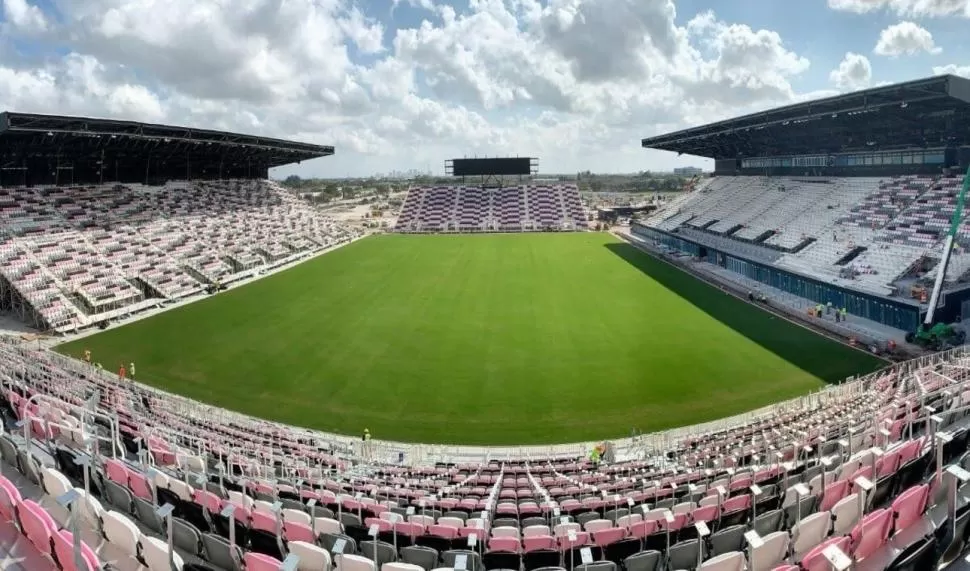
[632,75,970,330]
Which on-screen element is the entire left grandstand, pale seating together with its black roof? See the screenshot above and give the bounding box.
[0,113,355,333]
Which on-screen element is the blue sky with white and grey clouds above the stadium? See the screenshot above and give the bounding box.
[0,0,970,176]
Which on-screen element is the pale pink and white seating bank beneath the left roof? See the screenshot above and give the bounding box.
[0,181,357,332]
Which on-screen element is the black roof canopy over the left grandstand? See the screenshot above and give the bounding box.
[0,112,334,183]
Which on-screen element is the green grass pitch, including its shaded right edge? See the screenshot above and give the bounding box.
[58,233,882,445]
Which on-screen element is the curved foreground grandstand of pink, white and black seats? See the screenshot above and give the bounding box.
[0,326,970,571]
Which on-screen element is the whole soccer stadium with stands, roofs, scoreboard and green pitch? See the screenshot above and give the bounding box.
[7,69,970,571]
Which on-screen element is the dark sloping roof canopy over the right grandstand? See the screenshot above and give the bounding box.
[642,75,970,159]
